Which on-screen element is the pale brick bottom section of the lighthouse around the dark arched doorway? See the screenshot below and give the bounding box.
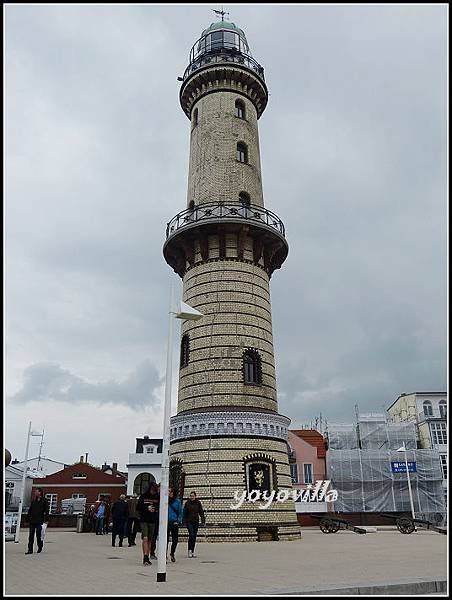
[170,413,300,542]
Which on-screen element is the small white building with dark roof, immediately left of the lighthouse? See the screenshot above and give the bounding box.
[126,435,163,495]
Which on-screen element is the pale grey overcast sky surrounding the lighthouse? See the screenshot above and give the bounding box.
[5,4,447,466]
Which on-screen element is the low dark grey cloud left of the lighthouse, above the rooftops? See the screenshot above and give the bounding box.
[12,360,161,410]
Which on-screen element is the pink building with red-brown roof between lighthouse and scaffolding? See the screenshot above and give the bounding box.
[288,429,331,526]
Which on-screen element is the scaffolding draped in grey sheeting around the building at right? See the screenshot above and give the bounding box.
[326,415,446,523]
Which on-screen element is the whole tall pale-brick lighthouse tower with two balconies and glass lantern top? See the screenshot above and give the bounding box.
[163,20,300,541]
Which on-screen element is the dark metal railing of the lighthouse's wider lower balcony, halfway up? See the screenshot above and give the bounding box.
[166,202,285,239]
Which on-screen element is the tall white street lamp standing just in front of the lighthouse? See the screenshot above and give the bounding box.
[157,285,203,581]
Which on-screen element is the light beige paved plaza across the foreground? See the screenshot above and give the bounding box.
[5,528,447,596]
